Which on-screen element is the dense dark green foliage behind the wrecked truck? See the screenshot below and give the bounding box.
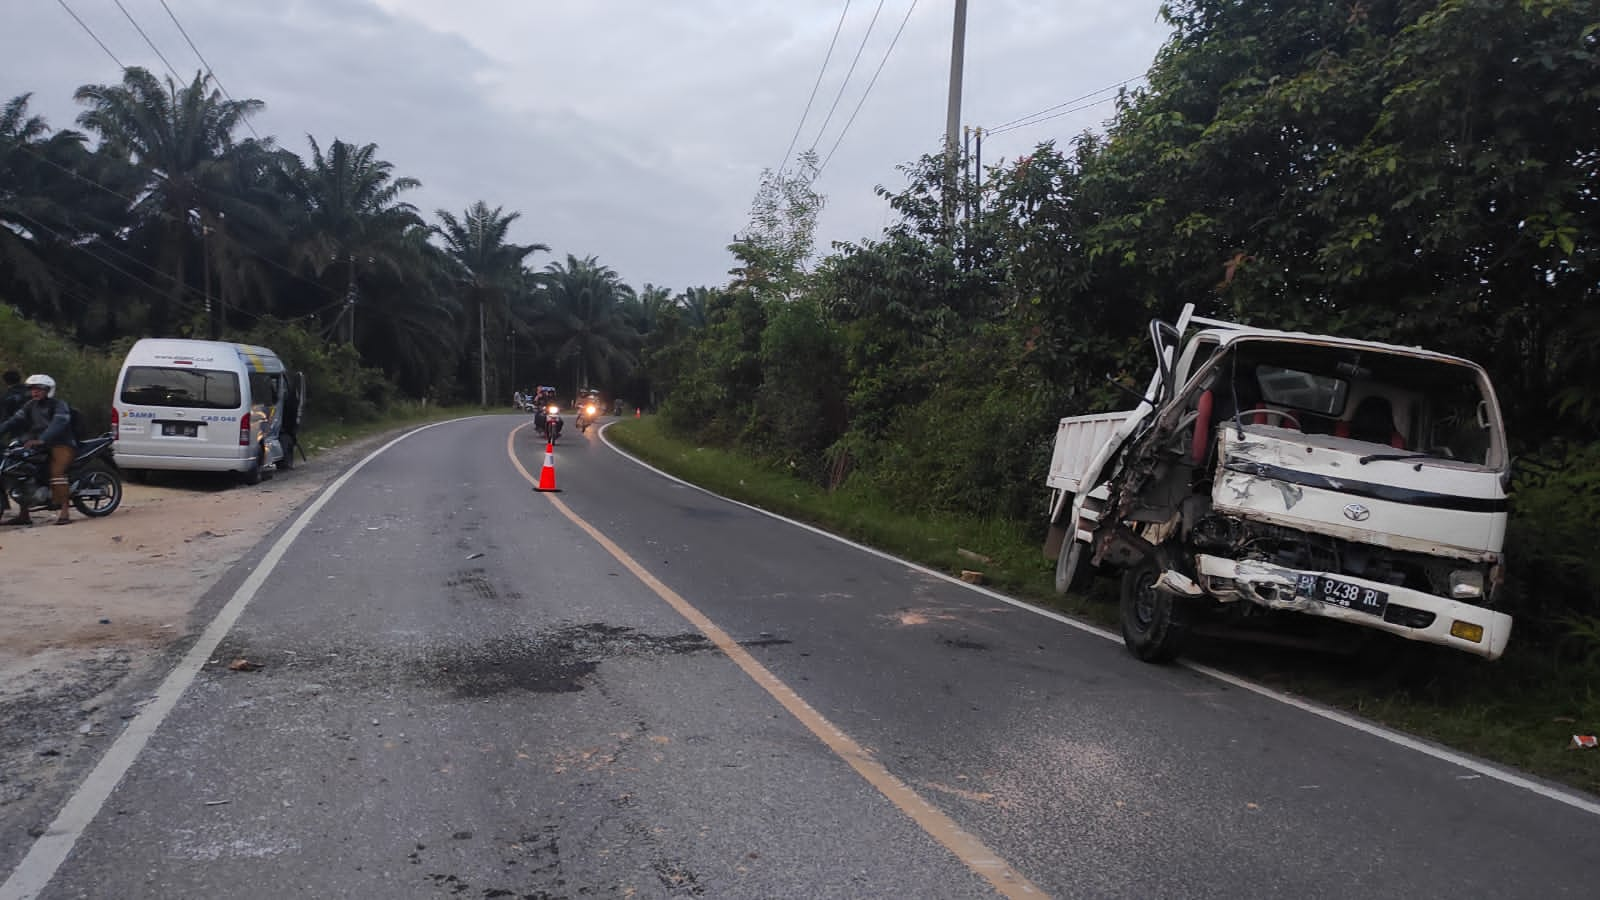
[648,0,1600,653]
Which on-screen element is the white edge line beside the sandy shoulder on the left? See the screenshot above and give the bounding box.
[0,416,477,900]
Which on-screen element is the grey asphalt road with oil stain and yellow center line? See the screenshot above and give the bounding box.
[0,416,1600,898]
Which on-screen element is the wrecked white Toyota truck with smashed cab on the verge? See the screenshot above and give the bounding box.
[1045,306,1512,661]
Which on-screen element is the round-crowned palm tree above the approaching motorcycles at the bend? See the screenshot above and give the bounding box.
[536,255,638,389]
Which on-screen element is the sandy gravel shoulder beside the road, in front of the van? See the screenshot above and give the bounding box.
[0,429,403,864]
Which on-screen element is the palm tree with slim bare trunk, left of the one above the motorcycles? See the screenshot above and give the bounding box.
[434,200,550,407]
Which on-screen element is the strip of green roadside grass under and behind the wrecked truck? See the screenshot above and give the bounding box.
[606,418,1600,793]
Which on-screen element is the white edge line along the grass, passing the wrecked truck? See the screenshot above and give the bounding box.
[595,423,1600,813]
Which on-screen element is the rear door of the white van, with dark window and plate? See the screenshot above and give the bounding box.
[117,364,250,460]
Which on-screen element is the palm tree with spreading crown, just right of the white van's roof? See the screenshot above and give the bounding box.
[283,135,422,344]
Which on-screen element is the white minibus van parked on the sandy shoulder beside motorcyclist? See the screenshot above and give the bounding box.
[110,338,306,484]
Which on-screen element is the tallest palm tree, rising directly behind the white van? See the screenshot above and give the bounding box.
[74,66,270,331]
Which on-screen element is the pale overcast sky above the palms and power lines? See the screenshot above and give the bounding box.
[0,0,1168,290]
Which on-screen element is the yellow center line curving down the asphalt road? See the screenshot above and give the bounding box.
[506,423,1045,897]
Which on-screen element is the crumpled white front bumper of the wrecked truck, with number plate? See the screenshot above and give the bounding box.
[1195,554,1512,660]
